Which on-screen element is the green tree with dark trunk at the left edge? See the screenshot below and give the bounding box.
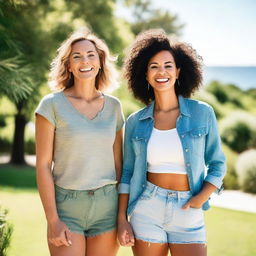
[0,1,53,164]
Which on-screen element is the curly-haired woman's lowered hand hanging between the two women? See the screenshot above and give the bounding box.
[117,220,134,246]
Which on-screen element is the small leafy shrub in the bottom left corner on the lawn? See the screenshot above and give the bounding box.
[0,208,13,256]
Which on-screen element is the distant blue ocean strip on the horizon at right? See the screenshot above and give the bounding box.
[204,66,256,90]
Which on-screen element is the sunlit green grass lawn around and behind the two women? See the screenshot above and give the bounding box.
[0,165,256,256]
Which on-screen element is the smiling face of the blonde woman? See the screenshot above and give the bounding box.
[68,40,100,81]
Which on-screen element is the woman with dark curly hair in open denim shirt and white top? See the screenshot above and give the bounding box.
[118,30,225,256]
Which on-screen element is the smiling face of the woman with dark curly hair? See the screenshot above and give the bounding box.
[146,51,180,91]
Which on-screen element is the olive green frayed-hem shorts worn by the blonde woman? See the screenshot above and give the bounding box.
[55,185,117,237]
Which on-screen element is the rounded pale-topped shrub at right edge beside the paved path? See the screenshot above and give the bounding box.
[236,149,256,193]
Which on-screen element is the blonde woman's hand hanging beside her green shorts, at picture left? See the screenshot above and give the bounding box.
[47,219,72,247]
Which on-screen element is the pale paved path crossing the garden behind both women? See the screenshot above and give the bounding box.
[0,155,256,213]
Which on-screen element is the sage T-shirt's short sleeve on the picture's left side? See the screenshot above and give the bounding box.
[35,94,56,126]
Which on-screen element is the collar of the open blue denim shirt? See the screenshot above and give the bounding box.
[139,95,190,120]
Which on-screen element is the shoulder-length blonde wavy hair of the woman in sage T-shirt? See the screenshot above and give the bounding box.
[49,28,117,91]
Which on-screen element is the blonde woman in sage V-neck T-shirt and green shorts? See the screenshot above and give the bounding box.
[35,30,124,256]
